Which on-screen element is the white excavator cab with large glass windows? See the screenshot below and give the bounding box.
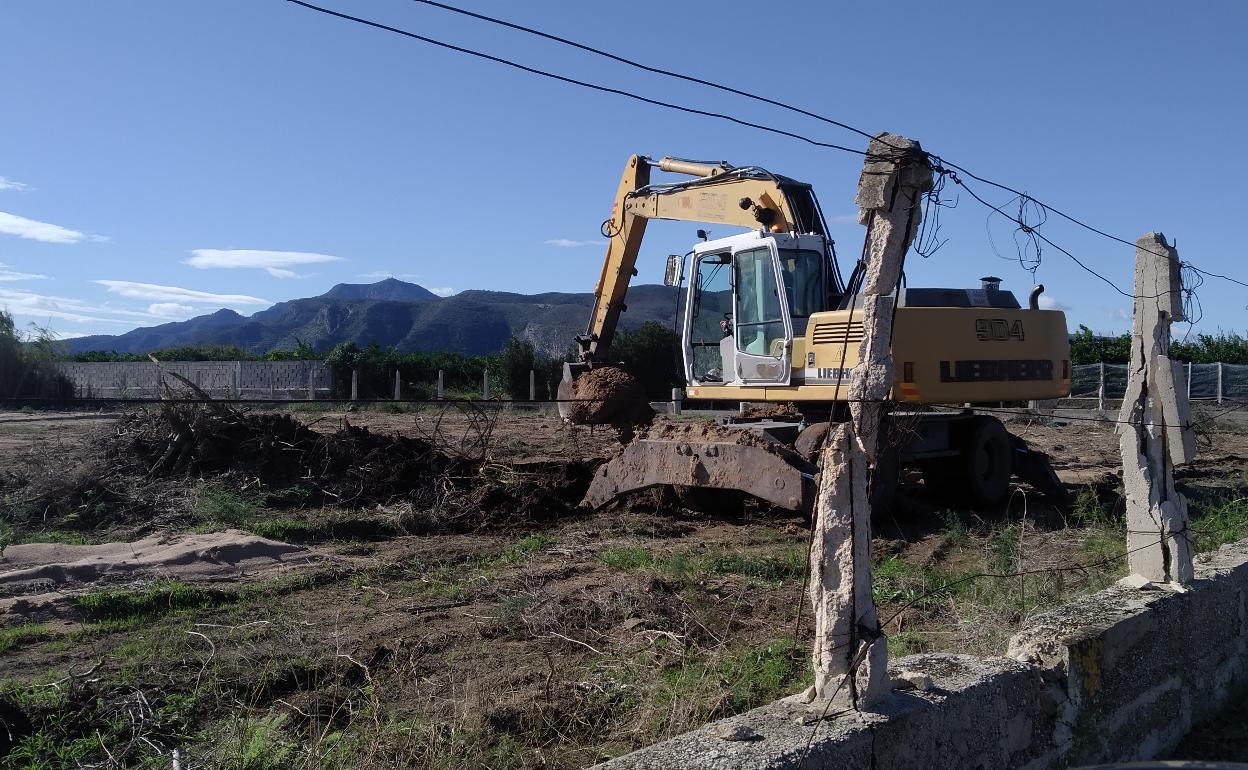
[681,231,829,387]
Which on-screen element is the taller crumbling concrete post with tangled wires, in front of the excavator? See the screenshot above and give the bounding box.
[810,134,932,708]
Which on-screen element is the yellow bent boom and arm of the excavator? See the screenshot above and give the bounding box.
[577,155,825,364]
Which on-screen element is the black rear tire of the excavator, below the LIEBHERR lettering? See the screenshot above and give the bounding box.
[920,416,1013,505]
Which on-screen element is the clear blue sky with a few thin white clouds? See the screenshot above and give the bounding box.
[0,0,1248,334]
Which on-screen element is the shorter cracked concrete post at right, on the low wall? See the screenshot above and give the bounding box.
[1118,232,1196,584]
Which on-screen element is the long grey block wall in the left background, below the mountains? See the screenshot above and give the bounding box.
[57,361,329,398]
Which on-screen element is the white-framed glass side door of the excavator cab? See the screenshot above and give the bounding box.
[725,238,792,386]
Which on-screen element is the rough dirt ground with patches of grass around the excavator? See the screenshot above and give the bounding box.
[0,408,1248,770]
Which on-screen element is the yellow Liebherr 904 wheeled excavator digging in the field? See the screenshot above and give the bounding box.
[560,155,1071,509]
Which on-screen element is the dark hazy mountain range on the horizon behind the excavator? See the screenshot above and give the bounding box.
[66,278,676,356]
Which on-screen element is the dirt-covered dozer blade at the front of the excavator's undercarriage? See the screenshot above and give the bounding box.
[582,438,816,510]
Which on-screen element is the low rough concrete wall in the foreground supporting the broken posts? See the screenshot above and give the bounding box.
[600,540,1248,770]
